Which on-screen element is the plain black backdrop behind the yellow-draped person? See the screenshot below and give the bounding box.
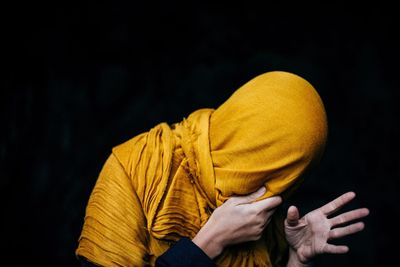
[0,1,400,266]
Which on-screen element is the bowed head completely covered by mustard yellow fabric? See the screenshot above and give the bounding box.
[209,71,328,204]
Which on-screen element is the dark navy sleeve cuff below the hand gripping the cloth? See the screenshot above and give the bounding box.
[156,237,217,267]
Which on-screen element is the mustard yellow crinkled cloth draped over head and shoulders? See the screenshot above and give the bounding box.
[76,72,327,266]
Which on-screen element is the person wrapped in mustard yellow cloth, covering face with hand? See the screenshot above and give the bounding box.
[76,71,368,266]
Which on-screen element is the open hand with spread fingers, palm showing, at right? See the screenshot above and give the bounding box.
[285,192,369,264]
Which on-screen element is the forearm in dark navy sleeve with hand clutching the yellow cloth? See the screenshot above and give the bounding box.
[156,187,282,267]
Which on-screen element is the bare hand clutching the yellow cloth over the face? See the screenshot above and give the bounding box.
[193,187,282,259]
